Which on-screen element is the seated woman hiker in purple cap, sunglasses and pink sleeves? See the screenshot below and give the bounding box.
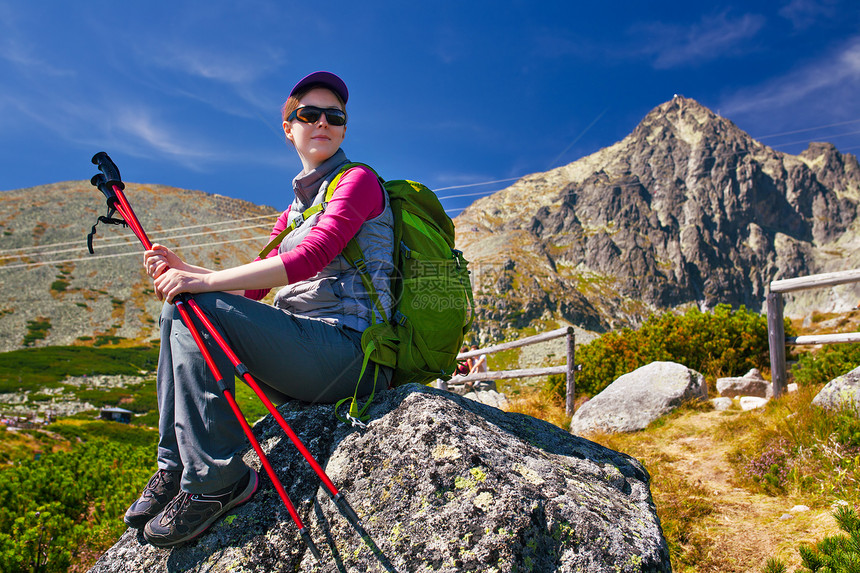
[125,72,394,547]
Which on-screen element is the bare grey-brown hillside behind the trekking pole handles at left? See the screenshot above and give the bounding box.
[0,181,278,351]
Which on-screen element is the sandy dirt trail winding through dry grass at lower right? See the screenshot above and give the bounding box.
[643,411,840,572]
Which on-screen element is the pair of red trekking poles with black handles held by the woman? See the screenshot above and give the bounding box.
[87,151,366,561]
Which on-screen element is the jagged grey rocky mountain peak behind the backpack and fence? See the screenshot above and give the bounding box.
[455,96,860,338]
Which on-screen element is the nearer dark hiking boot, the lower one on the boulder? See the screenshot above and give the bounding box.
[143,468,259,547]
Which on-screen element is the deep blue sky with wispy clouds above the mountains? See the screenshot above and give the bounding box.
[0,0,860,215]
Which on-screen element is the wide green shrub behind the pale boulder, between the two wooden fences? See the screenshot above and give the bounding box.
[560,305,791,396]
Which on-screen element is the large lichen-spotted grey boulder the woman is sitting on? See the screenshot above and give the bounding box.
[92,385,671,573]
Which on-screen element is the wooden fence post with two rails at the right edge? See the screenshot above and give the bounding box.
[767,269,860,397]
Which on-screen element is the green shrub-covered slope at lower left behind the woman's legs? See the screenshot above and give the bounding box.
[0,346,278,573]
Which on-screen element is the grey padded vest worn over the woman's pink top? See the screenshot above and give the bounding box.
[274,150,394,332]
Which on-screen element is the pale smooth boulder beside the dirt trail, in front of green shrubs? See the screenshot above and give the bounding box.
[570,362,708,435]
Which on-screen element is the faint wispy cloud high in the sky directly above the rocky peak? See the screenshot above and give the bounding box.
[630,13,765,69]
